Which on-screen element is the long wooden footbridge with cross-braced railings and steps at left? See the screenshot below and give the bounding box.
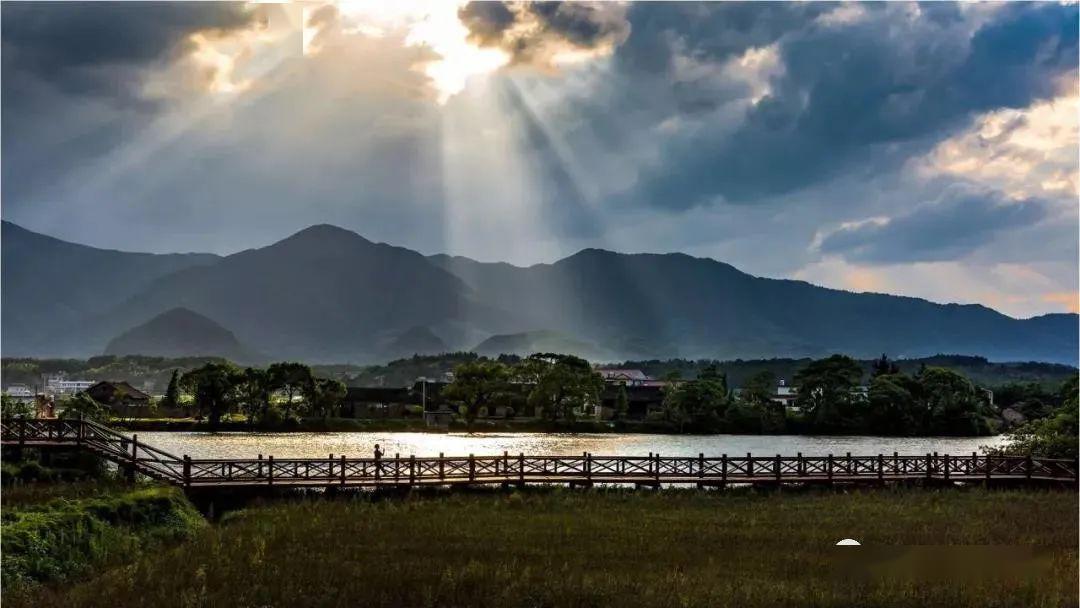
[0,419,1078,491]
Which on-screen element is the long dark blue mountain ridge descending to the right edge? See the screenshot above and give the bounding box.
[432,249,1078,364]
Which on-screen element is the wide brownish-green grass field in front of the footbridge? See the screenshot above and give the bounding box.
[11,489,1078,607]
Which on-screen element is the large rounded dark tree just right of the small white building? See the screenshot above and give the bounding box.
[795,354,863,432]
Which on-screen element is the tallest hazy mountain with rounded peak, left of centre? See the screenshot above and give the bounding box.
[76,226,518,361]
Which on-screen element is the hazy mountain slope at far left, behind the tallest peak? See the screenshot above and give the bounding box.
[0,221,219,356]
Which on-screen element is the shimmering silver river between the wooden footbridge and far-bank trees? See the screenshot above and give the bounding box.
[138,432,1005,458]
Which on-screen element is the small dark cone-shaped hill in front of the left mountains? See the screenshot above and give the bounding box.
[105,308,259,363]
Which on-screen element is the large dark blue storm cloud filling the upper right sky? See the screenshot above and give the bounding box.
[618,4,1078,208]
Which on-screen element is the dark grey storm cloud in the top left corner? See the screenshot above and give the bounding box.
[0,2,251,204]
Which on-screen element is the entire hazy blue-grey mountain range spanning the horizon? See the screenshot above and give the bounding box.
[0,221,1078,365]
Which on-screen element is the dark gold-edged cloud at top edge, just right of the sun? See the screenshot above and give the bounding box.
[458,2,629,64]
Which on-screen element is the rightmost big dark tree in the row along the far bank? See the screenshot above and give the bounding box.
[917,367,989,435]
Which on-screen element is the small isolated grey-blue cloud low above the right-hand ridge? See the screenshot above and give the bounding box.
[819,190,1048,264]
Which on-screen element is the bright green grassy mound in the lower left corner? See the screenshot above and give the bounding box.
[0,482,205,602]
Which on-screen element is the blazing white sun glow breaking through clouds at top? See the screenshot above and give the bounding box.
[337,0,510,103]
